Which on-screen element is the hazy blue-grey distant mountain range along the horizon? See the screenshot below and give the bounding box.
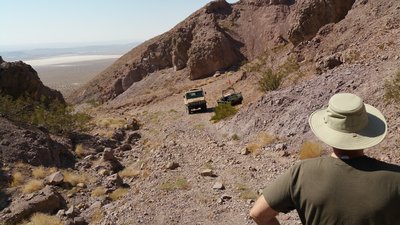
[0,42,140,61]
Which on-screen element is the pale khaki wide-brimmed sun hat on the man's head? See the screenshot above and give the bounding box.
[309,93,387,150]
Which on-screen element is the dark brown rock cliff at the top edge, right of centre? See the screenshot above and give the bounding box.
[289,0,355,45]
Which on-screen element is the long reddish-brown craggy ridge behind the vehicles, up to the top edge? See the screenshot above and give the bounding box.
[70,0,360,102]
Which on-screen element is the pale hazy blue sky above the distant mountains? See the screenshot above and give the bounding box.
[0,0,236,51]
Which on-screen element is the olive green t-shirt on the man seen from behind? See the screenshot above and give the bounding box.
[263,157,400,225]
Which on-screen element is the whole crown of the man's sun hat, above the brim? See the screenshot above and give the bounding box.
[324,93,368,133]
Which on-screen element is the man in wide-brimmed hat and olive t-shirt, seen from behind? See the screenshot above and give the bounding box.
[250,93,400,225]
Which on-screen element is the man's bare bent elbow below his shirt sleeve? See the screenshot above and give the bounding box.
[250,195,280,225]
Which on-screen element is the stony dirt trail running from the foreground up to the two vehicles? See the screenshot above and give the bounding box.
[86,70,298,224]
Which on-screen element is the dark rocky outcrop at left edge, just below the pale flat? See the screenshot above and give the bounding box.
[0,59,65,103]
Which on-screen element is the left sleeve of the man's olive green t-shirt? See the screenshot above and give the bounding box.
[263,164,295,213]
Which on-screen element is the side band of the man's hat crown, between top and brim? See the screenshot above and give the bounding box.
[324,105,368,133]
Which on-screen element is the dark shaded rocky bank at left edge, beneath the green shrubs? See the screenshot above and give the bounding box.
[0,118,75,167]
